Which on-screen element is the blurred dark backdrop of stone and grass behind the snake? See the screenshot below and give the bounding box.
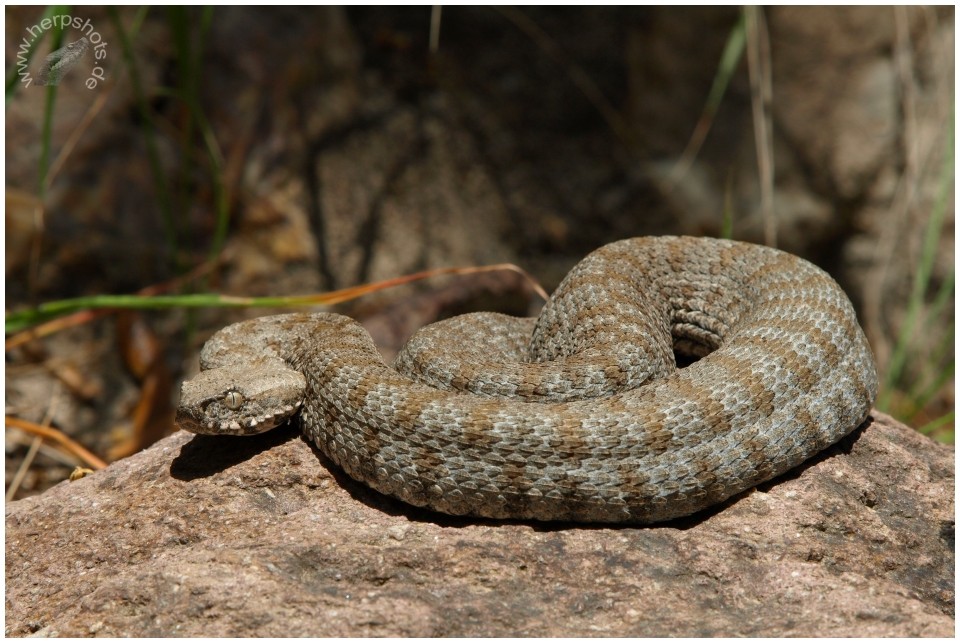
[5,6,955,498]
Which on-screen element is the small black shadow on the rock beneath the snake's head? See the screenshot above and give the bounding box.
[170,423,300,481]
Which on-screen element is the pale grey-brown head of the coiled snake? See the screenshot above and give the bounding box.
[176,365,306,435]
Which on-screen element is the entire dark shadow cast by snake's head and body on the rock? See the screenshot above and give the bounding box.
[170,416,874,533]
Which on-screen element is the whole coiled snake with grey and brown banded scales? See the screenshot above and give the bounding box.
[176,237,878,525]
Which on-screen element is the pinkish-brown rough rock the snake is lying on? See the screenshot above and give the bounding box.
[6,413,954,637]
